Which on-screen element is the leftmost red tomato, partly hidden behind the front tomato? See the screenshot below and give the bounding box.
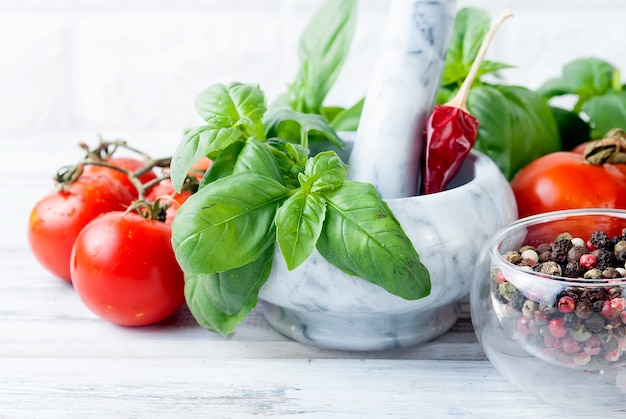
[27,175,133,282]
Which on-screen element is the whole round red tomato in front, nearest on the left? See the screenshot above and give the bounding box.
[71,212,185,326]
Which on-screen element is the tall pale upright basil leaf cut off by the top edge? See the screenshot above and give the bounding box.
[287,0,358,114]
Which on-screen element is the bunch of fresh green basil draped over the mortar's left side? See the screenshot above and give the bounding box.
[170,0,430,335]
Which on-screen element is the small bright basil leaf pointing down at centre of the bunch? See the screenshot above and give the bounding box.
[276,189,326,270]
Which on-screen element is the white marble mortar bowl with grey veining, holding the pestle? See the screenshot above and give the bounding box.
[259,151,517,351]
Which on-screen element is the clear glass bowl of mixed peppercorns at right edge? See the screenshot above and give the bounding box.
[470,209,626,411]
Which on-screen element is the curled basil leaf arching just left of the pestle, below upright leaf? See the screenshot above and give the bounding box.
[263,107,343,147]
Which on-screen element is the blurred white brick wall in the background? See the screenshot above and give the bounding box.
[0,0,626,136]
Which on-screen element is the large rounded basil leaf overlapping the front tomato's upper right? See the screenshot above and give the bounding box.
[172,173,289,274]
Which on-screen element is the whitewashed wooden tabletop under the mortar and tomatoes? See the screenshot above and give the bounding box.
[0,131,620,418]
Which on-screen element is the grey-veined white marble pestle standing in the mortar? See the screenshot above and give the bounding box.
[348,0,456,199]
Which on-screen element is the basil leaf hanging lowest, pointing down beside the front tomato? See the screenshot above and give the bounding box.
[185,245,274,336]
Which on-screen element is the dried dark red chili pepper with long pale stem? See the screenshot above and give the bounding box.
[421,10,512,194]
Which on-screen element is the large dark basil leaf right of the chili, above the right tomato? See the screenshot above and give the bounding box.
[467,85,561,180]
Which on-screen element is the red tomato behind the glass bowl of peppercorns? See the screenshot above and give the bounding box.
[511,151,626,218]
